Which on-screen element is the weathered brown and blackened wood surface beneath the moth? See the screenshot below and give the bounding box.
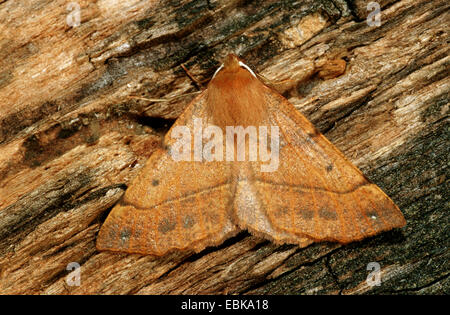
[0,0,450,294]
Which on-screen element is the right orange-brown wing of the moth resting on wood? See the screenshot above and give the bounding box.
[235,88,405,245]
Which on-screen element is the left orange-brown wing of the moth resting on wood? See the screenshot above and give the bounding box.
[97,93,238,256]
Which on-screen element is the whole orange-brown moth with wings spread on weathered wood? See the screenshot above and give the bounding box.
[97,55,405,255]
